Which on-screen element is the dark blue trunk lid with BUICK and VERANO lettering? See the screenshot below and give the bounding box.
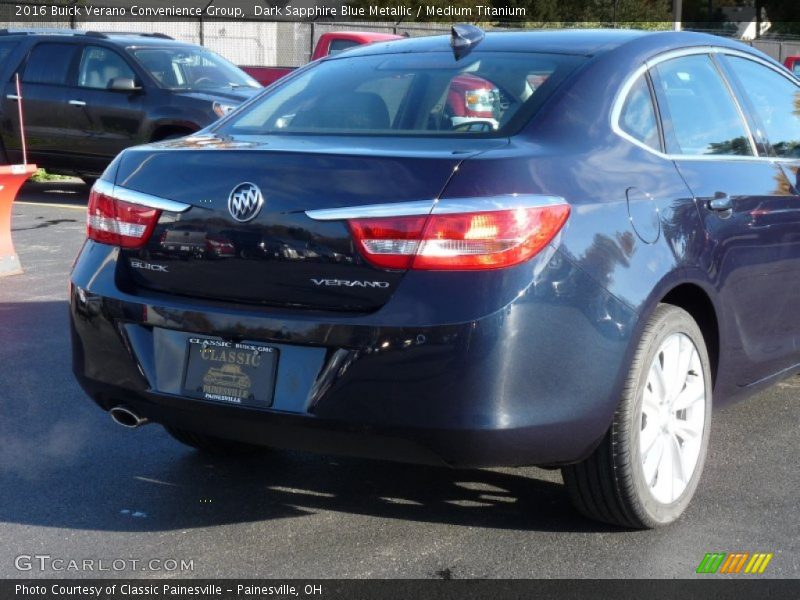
[116,136,504,311]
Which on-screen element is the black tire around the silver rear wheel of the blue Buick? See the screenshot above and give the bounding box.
[561,304,711,529]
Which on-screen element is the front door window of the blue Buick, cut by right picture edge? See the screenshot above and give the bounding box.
[725,56,800,158]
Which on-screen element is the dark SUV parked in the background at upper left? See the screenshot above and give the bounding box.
[0,29,261,181]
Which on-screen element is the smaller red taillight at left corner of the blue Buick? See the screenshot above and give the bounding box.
[86,182,161,248]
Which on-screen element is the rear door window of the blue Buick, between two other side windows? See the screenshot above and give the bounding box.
[654,54,754,156]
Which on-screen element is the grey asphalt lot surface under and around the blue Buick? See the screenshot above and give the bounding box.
[0,182,800,578]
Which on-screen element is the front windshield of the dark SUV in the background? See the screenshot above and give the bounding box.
[129,46,261,90]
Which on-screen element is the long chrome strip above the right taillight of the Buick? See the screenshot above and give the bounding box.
[306,194,567,221]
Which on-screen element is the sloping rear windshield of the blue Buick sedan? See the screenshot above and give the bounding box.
[218,52,583,137]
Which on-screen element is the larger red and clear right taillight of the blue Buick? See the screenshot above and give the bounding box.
[349,203,570,271]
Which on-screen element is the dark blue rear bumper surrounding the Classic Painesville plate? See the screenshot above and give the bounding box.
[71,243,635,466]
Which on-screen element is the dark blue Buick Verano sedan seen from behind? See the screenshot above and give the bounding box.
[71,27,800,527]
